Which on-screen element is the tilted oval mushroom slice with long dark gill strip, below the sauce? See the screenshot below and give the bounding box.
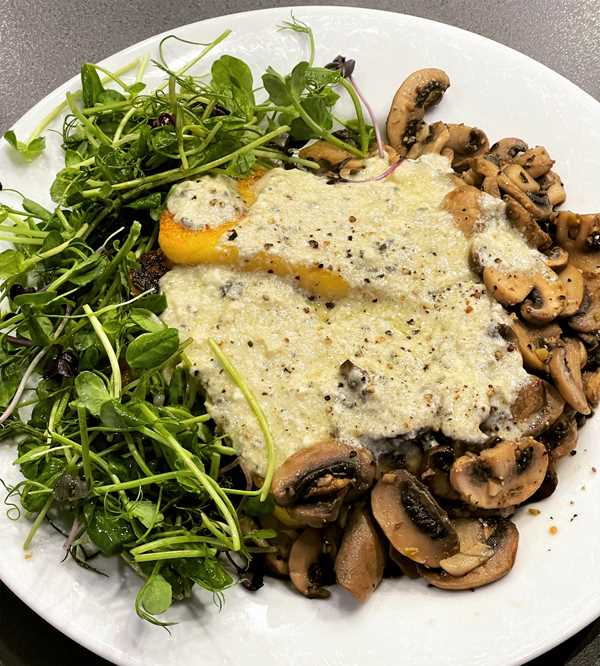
[371,470,458,567]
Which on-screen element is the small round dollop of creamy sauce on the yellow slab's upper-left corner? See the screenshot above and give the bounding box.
[168,176,244,230]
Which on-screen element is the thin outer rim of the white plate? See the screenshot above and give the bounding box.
[0,4,600,666]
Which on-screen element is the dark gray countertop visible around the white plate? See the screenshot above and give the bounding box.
[0,0,600,666]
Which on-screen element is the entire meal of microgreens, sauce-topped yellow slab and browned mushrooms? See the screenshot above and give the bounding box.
[0,16,600,625]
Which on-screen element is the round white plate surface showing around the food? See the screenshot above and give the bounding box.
[0,7,600,666]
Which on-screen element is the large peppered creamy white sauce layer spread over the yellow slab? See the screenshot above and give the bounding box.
[162,156,541,473]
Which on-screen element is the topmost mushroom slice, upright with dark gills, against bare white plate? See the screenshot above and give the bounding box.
[386,68,450,157]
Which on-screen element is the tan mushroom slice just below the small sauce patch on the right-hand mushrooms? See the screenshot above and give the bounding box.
[483,266,566,324]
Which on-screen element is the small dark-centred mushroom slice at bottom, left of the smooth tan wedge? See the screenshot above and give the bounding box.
[289,527,333,599]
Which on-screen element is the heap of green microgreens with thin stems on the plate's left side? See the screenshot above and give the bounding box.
[0,18,372,626]
